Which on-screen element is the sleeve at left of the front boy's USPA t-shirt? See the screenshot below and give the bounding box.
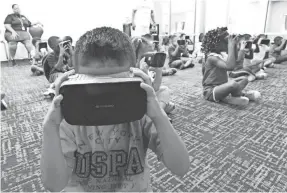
[60,121,77,169]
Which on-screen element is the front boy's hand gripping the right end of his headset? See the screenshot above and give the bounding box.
[131,68,162,120]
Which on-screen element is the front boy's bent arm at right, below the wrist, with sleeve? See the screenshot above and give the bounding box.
[144,111,190,176]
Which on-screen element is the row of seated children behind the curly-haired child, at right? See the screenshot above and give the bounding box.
[230,34,287,81]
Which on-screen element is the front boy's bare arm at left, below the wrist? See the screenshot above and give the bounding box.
[40,123,76,192]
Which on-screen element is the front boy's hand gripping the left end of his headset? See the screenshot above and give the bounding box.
[44,70,75,128]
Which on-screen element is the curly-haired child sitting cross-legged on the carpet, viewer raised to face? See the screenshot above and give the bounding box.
[202,28,260,105]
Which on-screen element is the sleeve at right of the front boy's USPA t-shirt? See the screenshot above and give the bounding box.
[142,116,162,161]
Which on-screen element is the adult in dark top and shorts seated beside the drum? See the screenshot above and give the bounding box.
[4,4,40,65]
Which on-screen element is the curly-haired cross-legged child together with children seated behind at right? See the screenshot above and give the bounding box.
[202,28,287,105]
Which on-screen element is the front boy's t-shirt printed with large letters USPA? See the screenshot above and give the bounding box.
[60,116,162,192]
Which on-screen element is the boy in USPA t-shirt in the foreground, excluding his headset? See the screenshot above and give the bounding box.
[41,27,189,192]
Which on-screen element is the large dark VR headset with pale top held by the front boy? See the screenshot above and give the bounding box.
[60,74,147,126]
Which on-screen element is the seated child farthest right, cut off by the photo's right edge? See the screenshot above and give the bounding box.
[269,36,287,64]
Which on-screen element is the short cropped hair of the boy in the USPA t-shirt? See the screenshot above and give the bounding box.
[75,27,136,67]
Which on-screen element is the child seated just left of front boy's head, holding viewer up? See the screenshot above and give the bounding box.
[45,36,73,83]
